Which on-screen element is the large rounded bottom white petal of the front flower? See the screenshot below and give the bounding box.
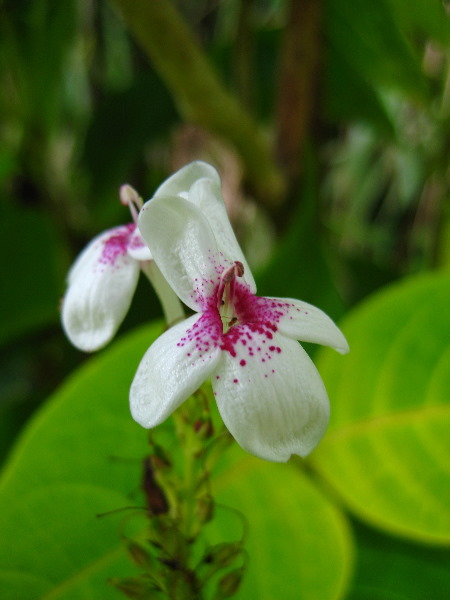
[213,333,329,462]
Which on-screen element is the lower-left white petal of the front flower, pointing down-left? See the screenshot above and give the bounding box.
[130,315,220,428]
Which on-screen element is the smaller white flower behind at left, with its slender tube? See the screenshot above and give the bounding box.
[62,185,183,352]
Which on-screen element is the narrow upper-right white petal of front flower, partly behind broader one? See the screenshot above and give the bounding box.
[188,179,256,293]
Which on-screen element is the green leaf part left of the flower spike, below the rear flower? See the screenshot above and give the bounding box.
[0,325,156,600]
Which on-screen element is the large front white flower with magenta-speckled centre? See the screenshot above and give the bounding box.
[130,162,348,461]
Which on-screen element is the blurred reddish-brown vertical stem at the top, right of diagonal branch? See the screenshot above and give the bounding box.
[276,0,321,187]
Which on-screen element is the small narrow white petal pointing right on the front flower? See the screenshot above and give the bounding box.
[266,298,349,354]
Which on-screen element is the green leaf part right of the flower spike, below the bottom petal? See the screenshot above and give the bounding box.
[216,449,353,600]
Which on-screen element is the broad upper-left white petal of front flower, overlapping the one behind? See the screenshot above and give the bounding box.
[139,196,227,311]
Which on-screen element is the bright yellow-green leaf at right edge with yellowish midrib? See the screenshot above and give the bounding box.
[311,274,450,544]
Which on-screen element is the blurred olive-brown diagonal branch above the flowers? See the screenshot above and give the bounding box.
[111,0,285,209]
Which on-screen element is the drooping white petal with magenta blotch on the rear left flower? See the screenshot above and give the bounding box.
[62,226,139,352]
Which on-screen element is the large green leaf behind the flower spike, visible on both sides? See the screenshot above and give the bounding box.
[0,325,352,600]
